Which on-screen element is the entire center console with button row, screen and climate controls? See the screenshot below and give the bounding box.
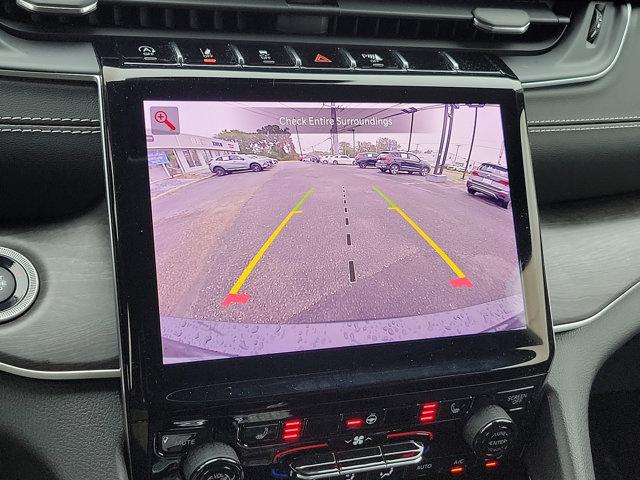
[99,40,553,480]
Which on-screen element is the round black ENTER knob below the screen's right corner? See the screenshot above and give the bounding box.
[463,405,518,458]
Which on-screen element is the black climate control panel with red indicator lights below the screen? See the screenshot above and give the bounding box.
[150,378,541,480]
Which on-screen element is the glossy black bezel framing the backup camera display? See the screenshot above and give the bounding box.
[106,70,552,402]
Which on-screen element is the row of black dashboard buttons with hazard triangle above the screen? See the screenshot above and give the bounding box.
[118,40,500,73]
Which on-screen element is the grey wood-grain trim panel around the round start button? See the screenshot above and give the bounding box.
[0,203,119,371]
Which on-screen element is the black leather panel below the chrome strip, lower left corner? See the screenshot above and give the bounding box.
[0,373,127,480]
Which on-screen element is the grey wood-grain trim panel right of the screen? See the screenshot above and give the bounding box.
[540,193,640,328]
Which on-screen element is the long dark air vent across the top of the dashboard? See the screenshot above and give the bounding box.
[0,0,573,53]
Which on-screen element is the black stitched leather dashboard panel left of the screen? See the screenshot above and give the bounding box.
[0,77,104,223]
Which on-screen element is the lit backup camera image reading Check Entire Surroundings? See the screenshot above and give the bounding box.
[144,99,526,364]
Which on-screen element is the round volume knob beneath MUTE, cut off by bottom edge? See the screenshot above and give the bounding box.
[182,442,243,480]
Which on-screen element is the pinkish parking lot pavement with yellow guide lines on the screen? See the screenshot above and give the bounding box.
[153,162,520,324]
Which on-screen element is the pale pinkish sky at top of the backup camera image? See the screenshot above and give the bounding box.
[145,101,504,163]
